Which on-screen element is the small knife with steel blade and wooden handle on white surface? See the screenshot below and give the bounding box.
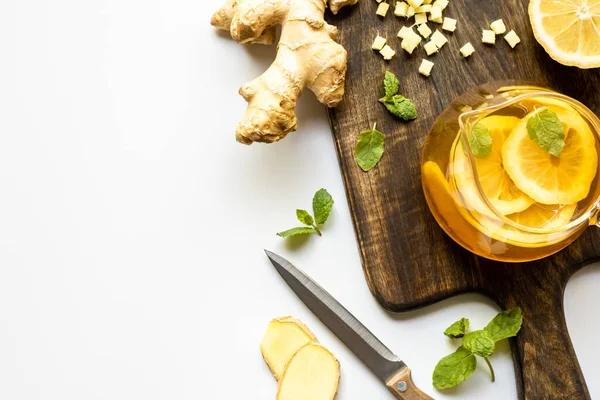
[265,250,432,400]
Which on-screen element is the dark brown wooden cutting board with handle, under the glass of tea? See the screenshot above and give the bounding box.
[329,0,600,400]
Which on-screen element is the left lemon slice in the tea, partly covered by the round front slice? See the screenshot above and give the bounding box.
[453,116,534,215]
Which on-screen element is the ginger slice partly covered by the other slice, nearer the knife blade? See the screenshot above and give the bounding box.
[260,317,317,380]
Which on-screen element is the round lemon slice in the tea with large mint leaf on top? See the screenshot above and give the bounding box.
[502,108,598,205]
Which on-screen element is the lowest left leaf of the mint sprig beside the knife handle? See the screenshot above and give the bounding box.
[433,346,477,389]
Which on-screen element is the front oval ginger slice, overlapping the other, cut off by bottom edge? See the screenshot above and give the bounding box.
[277,343,340,400]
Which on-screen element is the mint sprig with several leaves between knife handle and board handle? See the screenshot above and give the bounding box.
[432,308,523,389]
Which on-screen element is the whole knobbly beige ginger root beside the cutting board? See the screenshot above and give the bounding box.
[211,0,358,144]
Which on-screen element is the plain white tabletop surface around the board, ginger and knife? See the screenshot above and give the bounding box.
[0,0,600,400]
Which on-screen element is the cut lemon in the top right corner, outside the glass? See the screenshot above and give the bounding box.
[529,0,600,68]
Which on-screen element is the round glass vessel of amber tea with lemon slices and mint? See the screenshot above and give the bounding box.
[421,82,600,262]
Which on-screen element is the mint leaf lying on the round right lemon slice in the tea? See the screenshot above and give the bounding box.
[527,108,565,157]
